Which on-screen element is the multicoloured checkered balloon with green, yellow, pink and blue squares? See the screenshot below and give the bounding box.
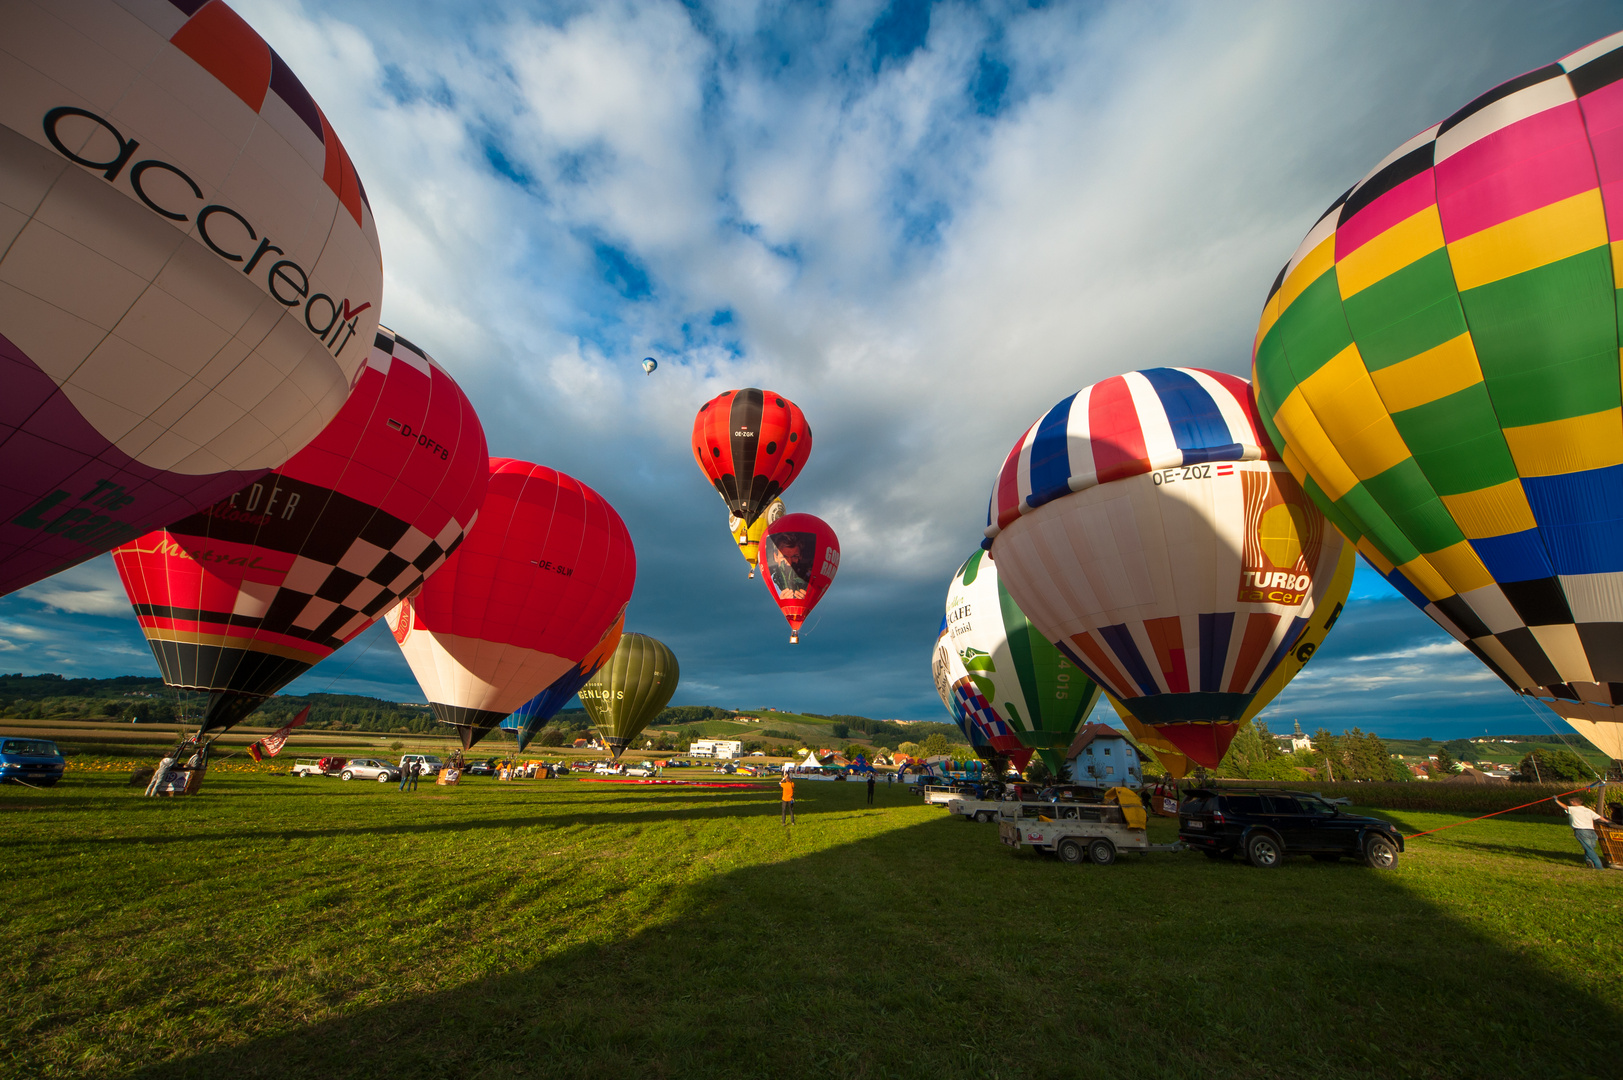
[1253,34,1623,757]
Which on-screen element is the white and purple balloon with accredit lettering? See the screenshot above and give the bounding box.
[0,0,383,593]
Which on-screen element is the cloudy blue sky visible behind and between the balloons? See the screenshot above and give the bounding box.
[0,0,1623,736]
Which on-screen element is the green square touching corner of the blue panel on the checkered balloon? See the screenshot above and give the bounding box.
[1393,383,1516,495]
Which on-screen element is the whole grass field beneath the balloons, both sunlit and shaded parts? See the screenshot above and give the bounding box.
[0,773,1623,1080]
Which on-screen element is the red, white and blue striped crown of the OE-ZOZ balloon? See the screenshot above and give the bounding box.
[985,367,1279,539]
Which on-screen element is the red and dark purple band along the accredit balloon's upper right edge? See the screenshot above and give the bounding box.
[169,0,370,226]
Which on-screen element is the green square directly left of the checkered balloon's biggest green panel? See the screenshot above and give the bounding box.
[1342,248,1466,372]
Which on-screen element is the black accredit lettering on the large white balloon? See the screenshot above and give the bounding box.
[42,106,376,362]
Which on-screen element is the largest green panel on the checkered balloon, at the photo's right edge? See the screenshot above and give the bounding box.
[1459,247,1623,427]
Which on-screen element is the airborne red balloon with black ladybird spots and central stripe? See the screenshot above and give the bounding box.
[693,387,812,525]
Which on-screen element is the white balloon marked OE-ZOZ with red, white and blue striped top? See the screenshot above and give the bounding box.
[987,367,1342,768]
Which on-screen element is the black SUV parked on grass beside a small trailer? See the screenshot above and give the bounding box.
[1178,789,1404,870]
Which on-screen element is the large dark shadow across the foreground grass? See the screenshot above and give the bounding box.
[120,799,1623,1080]
